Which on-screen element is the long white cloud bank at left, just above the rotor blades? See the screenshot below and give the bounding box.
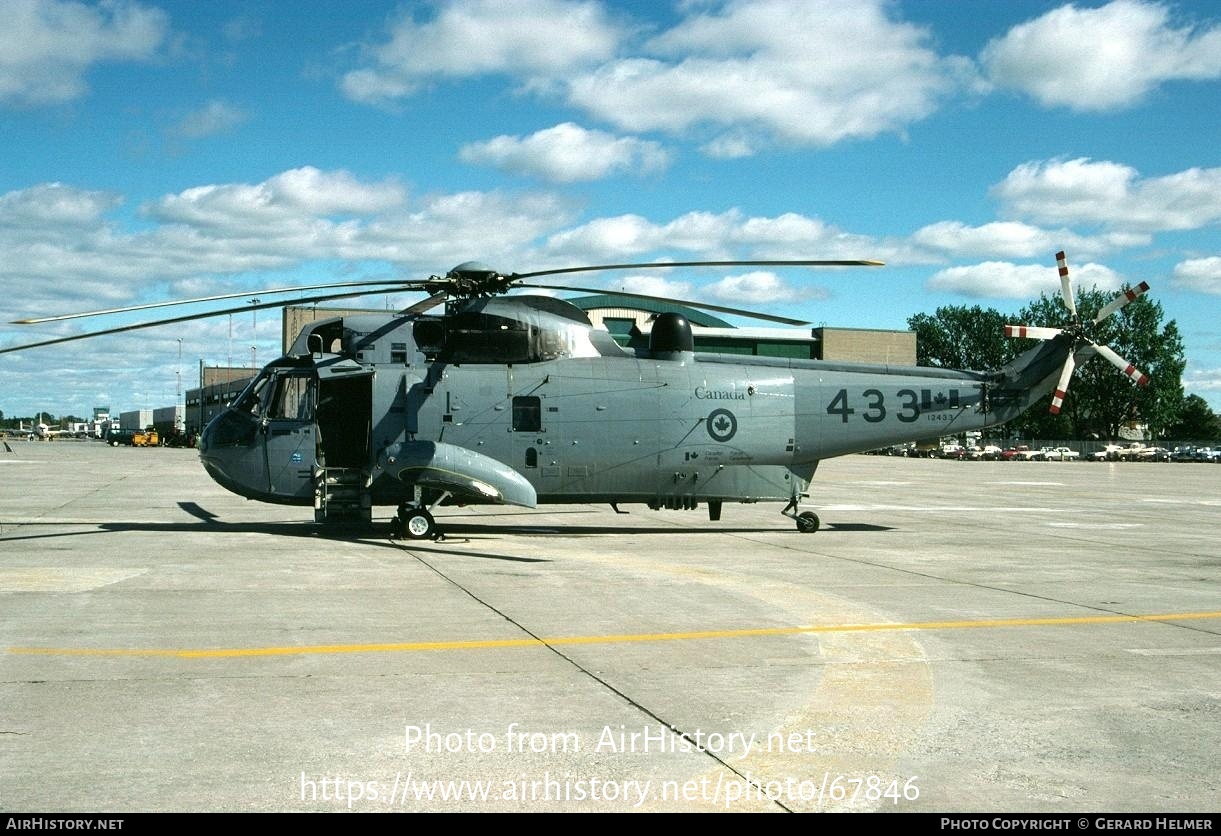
[0,168,585,327]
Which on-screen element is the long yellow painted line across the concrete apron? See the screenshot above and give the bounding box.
[9,610,1221,659]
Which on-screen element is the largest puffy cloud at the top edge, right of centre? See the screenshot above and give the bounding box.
[569,0,965,157]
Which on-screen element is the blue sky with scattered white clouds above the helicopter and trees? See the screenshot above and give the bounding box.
[0,0,1221,416]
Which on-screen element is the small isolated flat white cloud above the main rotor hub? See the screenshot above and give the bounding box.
[459,122,669,183]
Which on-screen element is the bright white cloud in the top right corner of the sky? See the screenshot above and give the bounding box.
[980,0,1221,111]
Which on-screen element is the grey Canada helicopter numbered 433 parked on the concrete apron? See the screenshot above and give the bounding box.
[7,253,1149,539]
